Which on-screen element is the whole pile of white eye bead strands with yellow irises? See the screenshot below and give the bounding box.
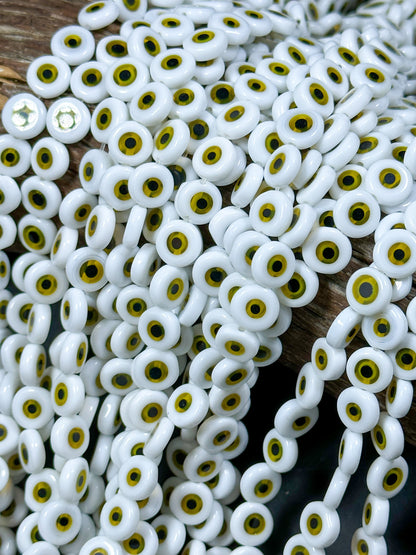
[0,0,416,555]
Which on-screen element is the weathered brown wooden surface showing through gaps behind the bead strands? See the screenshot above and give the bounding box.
[0,0,416,445]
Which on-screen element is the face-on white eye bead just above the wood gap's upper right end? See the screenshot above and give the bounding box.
[334,190,380,238]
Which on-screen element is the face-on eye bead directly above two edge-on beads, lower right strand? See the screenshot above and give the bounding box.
[337,387,380,434]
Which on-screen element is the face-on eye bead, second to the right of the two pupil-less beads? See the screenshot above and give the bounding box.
[108,121,153,166]
